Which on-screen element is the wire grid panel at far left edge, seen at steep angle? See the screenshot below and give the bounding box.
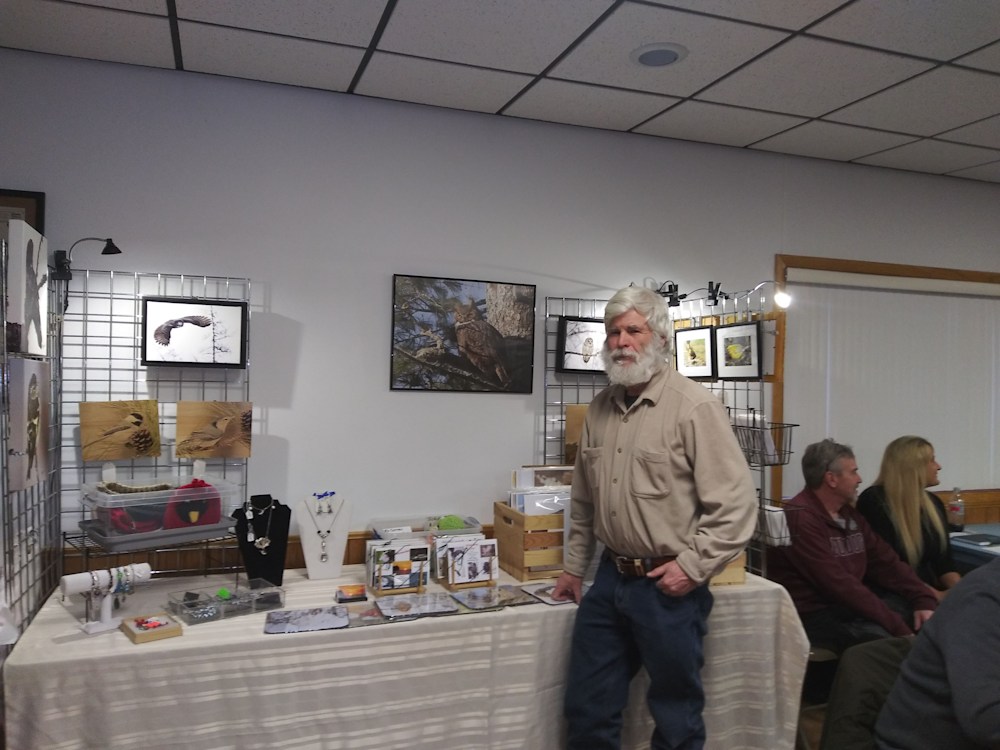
[0,244,62,661]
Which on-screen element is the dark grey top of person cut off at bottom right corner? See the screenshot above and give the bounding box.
[875,559,1000,750]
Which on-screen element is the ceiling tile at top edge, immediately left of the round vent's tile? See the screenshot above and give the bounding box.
[379,0,614,74]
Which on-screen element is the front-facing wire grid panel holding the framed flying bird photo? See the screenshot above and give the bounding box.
[59,270,250,533]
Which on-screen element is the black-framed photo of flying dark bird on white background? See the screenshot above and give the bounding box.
[142,297,249,370]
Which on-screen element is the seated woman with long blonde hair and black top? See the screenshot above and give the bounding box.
[857,435,961,600]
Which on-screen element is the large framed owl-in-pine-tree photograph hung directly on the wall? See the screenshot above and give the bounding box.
[389,274,535,393]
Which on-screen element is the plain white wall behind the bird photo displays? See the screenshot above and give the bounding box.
[0,50,1000,528]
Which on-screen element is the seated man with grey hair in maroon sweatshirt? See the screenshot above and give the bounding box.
[767,439,937,653]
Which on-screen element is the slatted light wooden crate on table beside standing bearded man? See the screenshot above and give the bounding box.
[493,502,564,581]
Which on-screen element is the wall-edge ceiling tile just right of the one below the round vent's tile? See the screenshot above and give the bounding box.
[634,101,805,146]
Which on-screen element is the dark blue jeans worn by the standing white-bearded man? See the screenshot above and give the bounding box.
[565,560,712,750]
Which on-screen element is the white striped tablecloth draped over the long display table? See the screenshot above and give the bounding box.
[4,567,808,750]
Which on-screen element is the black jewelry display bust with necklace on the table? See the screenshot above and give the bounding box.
[233,495,292,586]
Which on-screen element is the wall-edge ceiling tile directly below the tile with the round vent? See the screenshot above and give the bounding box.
[504,80,678,130]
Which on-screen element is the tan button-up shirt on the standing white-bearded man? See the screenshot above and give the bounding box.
[565,366,757,583]
